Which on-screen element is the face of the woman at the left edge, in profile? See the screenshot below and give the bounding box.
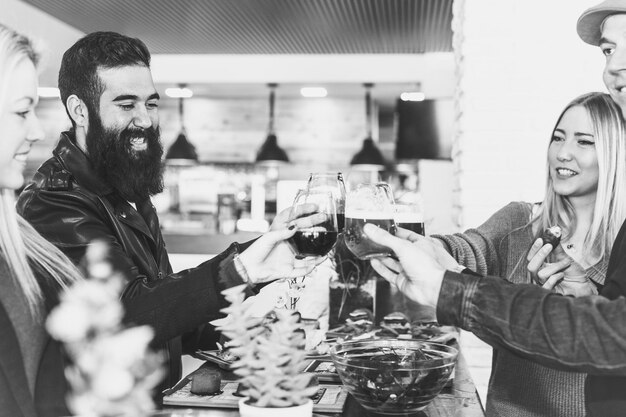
[0,59,44,189]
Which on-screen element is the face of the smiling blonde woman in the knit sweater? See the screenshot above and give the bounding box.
[548,106,599,200]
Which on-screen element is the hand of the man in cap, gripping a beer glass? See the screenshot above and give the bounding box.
[363,224,446,307]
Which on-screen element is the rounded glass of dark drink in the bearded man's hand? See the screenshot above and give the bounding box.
[288,190,339,259]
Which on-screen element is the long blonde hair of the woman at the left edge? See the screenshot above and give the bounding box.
[0,25,82,316]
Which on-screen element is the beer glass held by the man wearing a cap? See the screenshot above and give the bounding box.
[344,182,396,260]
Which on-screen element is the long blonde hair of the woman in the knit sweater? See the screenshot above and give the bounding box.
[534,93,626,257]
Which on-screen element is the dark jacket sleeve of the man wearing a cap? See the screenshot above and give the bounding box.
[437,272,626,375]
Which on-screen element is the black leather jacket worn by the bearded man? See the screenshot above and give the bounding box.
[17,132,249,387]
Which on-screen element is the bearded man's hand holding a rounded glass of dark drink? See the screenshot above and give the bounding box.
[239,204,326,284]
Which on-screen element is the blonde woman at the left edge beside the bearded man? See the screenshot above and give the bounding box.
[0,25,80,417]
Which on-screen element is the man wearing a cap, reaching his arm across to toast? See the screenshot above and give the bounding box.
[364,0,626,417]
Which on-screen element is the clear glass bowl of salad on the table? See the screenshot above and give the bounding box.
[330,339,459,415]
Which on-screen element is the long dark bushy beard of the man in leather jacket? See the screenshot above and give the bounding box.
[87,115,163,202]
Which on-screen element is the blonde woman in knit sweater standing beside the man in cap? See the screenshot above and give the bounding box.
[433,93,626,417]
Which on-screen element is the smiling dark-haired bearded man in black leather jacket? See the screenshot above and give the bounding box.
[18,32,323,394]
